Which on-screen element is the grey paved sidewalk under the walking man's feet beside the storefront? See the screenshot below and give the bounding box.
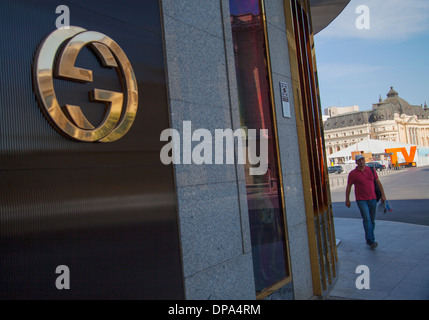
[327,218,429,300]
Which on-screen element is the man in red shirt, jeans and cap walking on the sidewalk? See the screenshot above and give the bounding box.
[346,155,386,249]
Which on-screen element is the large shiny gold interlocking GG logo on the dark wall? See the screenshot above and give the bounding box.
[34,26,138,142]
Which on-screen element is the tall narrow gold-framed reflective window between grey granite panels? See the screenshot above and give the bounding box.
[229,0,290,294]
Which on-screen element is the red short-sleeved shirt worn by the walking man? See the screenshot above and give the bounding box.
[347,166,378,200]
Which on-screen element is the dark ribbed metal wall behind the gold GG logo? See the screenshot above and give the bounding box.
[0,0,183,299]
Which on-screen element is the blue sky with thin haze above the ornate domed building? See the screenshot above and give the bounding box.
[314,0,429,110]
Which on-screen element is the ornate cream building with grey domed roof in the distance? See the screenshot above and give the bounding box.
[324,87,429,155]
